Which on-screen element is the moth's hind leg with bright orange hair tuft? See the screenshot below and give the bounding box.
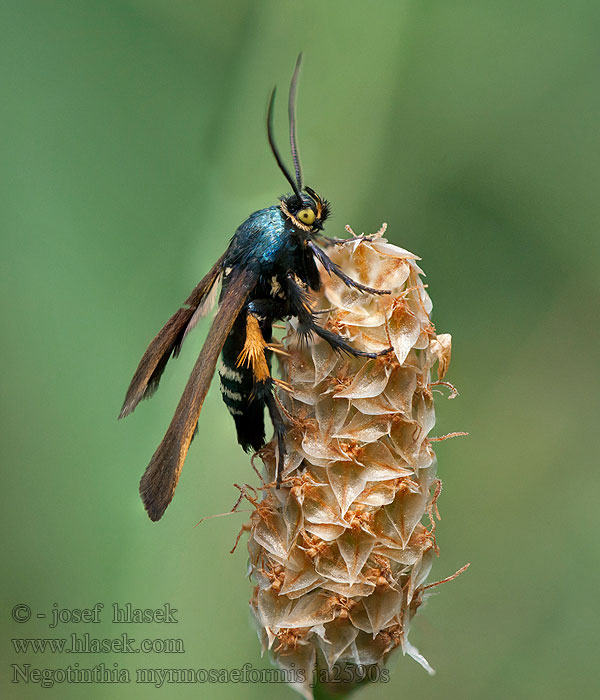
[238,299,286,488]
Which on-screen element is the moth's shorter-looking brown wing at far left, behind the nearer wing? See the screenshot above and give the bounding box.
[119,255,225,418]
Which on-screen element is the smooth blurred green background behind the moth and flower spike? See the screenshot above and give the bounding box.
[0,0,600,700]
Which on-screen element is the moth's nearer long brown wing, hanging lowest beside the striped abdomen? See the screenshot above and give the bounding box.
[140,269,257,520]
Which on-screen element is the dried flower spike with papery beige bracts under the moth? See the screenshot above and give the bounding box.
[241,227,458,699]
